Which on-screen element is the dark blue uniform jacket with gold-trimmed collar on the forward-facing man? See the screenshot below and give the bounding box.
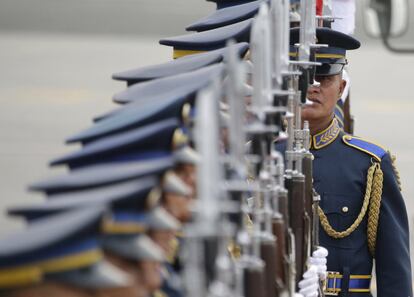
[276,119,413,297]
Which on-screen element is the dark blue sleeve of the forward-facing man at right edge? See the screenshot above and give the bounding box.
[375,154,413,297]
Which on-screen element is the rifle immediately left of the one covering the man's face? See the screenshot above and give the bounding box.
[272,0,302,295]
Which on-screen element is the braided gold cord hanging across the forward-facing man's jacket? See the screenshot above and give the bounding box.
[318,163,383,256]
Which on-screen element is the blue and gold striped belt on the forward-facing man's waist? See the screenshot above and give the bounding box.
[324,271,371,296]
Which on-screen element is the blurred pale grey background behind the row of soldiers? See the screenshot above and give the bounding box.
[0,0,414,251]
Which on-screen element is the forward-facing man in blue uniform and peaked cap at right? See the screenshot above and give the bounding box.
[277,28,412,297]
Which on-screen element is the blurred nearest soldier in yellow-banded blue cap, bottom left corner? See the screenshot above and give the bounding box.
[0,207,135,297]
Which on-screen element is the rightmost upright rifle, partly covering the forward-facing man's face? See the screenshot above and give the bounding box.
[286,0,332,294]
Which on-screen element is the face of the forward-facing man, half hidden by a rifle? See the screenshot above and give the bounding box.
[302,74,346,122]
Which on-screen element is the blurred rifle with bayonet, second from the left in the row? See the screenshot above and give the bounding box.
[226,38,269,297]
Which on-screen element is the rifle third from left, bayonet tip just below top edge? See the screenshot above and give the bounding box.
[250,4,292,296]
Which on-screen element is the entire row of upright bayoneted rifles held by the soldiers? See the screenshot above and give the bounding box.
[180,0,329,297]
